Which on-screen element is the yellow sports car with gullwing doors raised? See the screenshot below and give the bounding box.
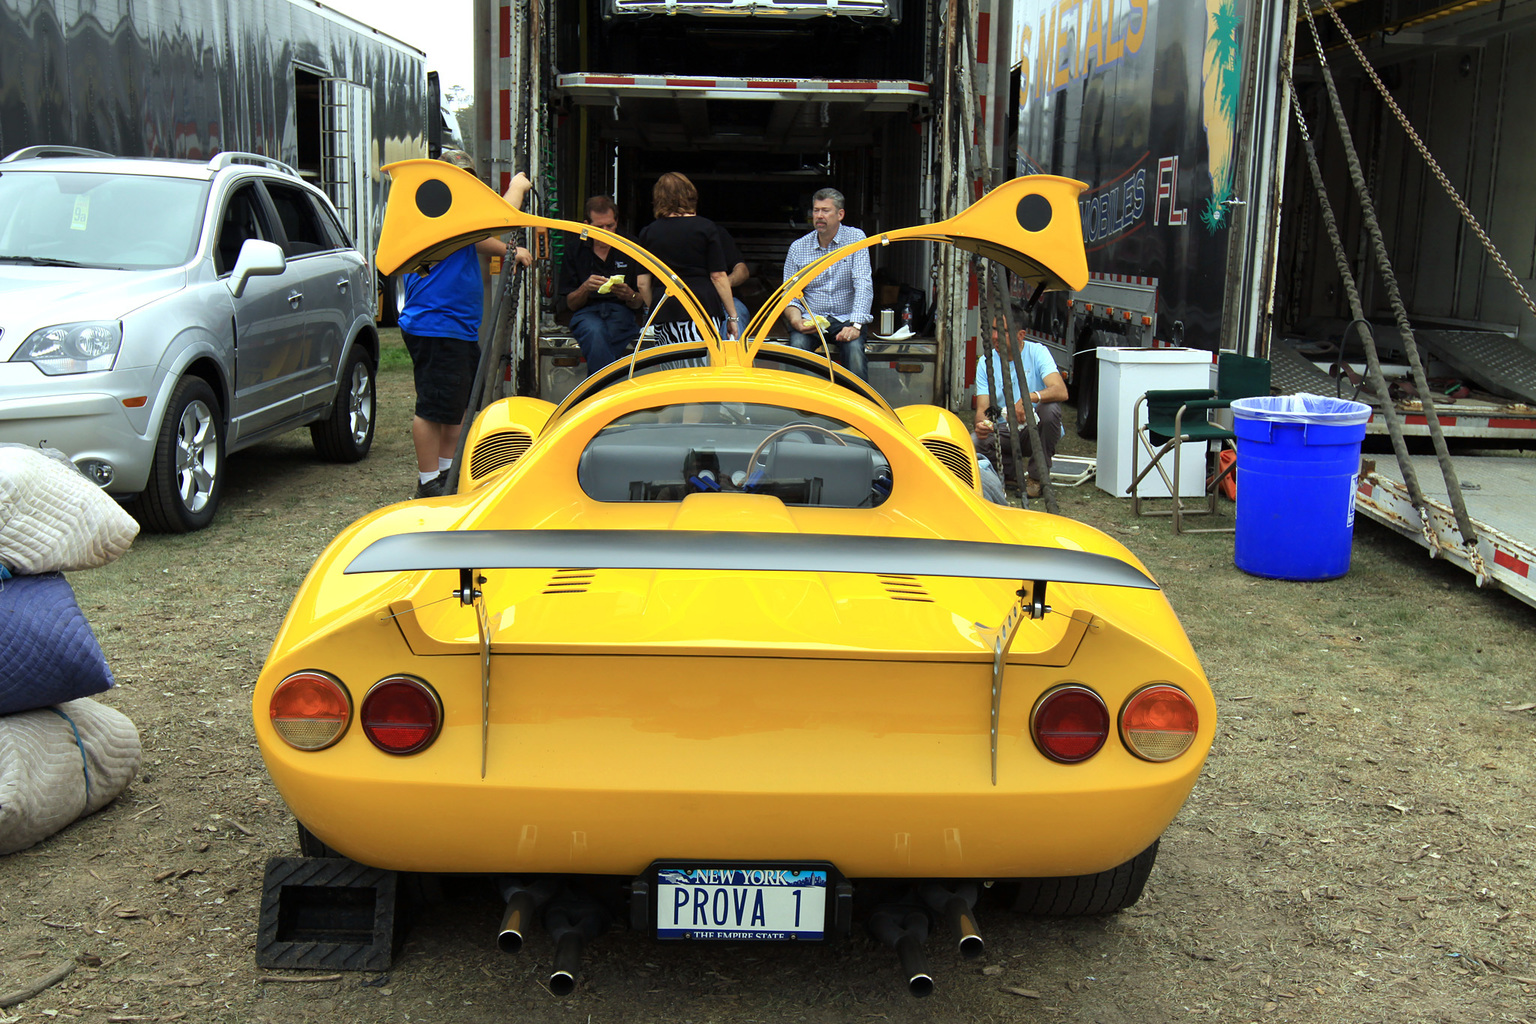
[253,161,1217,995]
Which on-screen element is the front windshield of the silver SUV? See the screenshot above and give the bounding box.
[0,170,209,270]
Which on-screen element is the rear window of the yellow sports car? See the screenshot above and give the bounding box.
[576,402,891,508]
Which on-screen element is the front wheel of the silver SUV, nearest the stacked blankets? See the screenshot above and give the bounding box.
[134,376,224,533]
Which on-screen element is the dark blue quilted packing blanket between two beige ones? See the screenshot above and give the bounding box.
[0,573,112,714]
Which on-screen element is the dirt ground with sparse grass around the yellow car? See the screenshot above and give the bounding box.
[0,346,1536,1024]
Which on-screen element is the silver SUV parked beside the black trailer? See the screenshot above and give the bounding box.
[0,146,378,533]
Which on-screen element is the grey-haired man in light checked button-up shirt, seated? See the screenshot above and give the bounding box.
[783,189,874,378]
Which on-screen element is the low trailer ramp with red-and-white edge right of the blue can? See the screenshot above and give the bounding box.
[1355,454,1536,608]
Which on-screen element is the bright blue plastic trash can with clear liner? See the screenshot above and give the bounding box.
[1232,395,1370,580]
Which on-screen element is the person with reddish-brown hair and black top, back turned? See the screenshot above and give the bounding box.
[636,172,740,344]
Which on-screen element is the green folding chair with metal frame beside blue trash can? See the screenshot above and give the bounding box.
[1129,352,1269,533]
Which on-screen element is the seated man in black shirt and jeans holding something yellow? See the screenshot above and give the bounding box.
[561,195,644,376]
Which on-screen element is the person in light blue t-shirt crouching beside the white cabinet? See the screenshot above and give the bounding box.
[971,310,1066,505]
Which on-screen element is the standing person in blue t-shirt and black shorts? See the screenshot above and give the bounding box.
[399,149,531,497]
